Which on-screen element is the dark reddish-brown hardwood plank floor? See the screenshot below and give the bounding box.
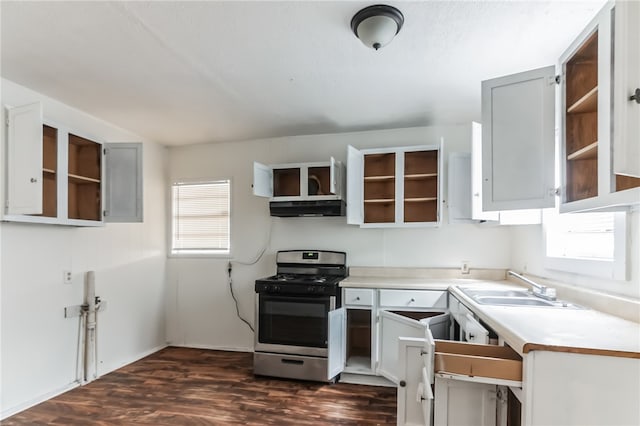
[1,347,396,426]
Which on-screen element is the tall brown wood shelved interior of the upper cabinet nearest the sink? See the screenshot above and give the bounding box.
[565,31,598,202]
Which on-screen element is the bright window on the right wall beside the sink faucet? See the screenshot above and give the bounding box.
[543,209,627,280]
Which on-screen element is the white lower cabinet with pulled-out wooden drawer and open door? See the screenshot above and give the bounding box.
[398,328,522,426]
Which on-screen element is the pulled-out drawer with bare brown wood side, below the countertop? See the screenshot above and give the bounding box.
[434,340,522,385]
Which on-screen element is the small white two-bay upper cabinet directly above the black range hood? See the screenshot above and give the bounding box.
[253,157,344,201]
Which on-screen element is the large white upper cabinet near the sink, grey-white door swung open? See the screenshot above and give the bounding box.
[482,2,640,212]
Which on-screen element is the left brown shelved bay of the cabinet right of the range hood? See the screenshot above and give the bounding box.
[364,153,396,223]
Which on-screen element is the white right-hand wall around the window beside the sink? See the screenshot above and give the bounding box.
[510,211,640,300]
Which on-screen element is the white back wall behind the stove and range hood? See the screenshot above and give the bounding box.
[167,126,511,350]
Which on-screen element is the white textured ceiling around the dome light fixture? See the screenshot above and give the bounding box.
[0,0,604,145]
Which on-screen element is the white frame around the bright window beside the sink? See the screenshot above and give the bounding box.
[542,208,629,281]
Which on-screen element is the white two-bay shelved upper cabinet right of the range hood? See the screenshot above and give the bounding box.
[347,142,442,228]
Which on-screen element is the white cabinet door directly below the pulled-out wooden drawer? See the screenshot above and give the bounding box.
[433,377,496,426]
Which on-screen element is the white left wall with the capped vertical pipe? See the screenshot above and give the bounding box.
[0,80,167,417]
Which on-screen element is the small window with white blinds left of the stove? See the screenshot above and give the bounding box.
[171,180,231,255]
